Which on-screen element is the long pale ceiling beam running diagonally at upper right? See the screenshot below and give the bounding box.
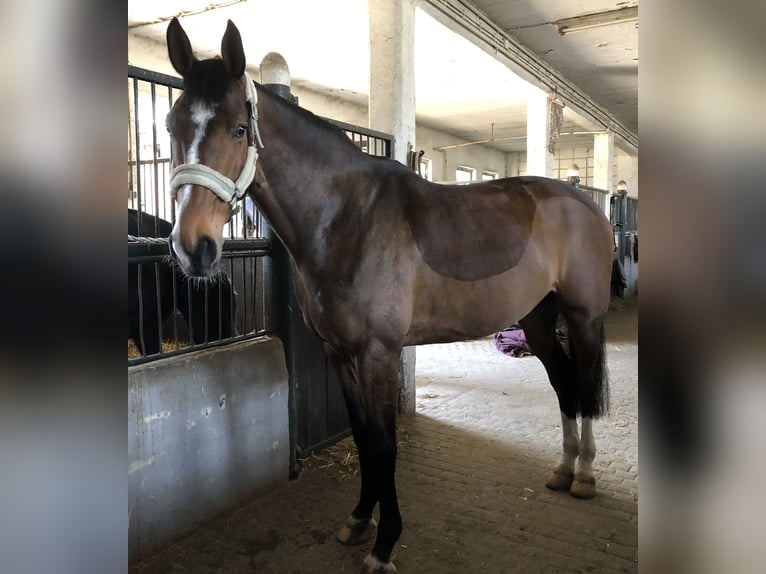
[421,0,638,151]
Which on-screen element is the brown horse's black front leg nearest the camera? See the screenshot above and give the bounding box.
[340,340,402,574]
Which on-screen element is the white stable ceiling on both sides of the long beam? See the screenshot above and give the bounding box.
[128,0,638,152]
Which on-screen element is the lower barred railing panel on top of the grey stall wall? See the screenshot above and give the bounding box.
[128,238,271,365]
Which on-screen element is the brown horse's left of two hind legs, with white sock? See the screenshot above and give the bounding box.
[520,293,580,490]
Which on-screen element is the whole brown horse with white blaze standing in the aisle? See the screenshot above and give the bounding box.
[167,19,612,573]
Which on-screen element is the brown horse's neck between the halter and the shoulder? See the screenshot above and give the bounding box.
[253,86,367,267]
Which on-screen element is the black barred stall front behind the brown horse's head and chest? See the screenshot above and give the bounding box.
[128,66,393,468]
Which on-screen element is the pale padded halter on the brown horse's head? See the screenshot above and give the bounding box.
[170,72,264,215]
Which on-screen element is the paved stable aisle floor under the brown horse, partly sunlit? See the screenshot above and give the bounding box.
[130,300,638,574]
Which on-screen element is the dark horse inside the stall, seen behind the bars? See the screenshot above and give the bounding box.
[128,209,236,355]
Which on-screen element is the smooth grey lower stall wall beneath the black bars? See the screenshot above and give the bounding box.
[128,337,290,562]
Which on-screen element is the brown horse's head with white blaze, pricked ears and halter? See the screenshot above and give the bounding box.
[166,18,258,277]
